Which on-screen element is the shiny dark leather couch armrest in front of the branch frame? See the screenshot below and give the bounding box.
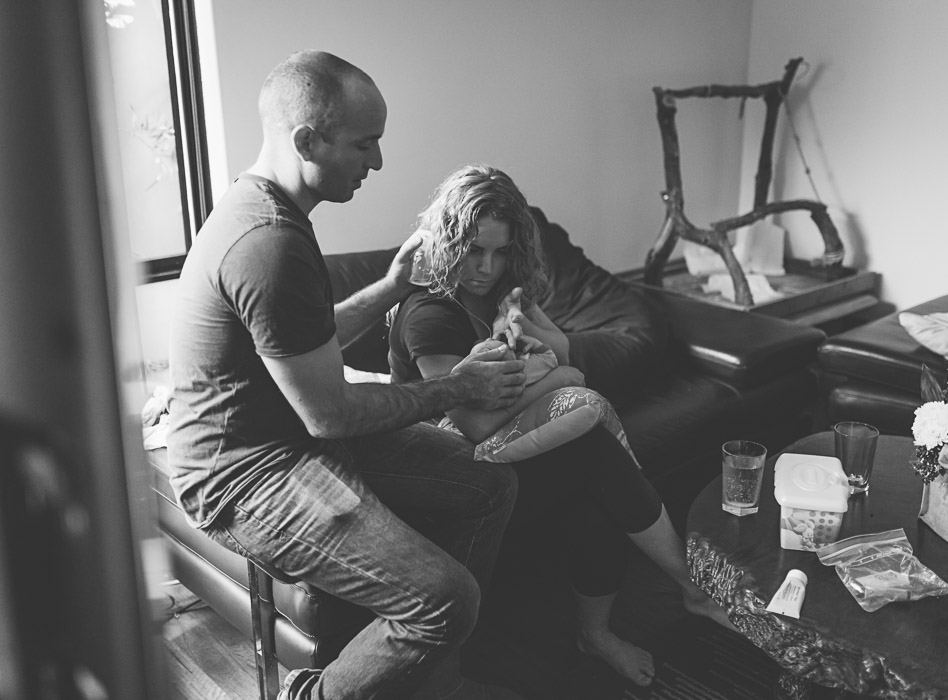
[661,292,826,387]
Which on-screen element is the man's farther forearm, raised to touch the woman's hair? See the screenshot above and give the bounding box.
[334,230,424,347]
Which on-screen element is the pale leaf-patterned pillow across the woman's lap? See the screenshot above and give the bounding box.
[466,386,634,462]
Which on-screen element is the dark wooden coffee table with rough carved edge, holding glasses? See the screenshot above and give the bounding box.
[688,432,948,700]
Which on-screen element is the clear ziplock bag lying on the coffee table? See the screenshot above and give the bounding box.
[816,528,948,612]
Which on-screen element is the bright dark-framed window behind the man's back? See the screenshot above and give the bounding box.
[105,0,211,283]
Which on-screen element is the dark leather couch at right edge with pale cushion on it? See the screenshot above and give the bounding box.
[819,296,948,436]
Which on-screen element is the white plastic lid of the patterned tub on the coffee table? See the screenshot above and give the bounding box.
[774,453,849,513]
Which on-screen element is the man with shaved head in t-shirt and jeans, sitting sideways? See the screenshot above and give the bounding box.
[168,51,524,700]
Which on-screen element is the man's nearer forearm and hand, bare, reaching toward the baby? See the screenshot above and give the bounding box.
[262,337,524,438]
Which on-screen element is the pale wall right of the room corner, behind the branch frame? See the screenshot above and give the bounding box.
[741,0,948,308]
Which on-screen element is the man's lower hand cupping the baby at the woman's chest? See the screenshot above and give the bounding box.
[451,341,526,411]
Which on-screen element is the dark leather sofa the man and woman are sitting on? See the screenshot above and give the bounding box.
[149,209,825,680]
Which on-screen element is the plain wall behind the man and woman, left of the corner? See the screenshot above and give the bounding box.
[213,0,751,270]
